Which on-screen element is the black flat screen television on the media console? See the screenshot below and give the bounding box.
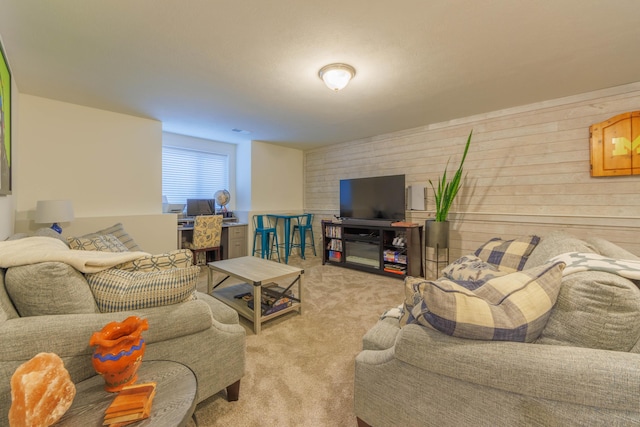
[340,175,406,221]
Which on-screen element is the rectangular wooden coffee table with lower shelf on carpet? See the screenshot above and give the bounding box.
[207,256,304,335]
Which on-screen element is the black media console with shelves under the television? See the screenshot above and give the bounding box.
[322,221,423,278]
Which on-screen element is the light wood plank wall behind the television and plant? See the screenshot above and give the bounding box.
[304,82,640,260]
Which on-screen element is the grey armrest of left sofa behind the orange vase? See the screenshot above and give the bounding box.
[0,300,213,362]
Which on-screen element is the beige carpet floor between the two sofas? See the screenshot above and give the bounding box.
[190,256,403,427]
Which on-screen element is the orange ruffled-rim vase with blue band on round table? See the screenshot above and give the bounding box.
[89,316,149,392]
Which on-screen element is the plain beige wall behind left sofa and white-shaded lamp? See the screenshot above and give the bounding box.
[14,94,176,252]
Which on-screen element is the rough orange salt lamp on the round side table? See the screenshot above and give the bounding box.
[9,353,76,427]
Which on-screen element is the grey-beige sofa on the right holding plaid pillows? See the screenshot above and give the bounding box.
[355,232,640,427]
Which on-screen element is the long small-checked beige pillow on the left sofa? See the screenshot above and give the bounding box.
[86,266,200,313]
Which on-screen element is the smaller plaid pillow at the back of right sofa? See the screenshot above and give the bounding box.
[475,236,540,273]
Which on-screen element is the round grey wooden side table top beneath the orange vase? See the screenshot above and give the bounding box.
[55,360,197,427]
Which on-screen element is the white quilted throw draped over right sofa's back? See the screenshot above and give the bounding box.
[549,252,640,280]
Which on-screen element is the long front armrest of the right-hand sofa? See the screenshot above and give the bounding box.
[394,325,640,412]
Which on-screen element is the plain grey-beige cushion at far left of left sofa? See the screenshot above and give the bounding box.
[5,262,100,317]
